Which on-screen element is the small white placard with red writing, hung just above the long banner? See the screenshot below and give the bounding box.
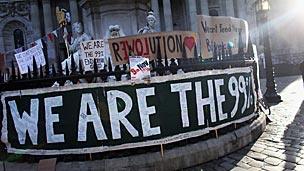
[129,56,151,81]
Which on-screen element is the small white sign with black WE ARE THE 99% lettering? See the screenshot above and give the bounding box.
[80,39,104,71]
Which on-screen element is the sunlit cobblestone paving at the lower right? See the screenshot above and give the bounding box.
[185,76,304,171]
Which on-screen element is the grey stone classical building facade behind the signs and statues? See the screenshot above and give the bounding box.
[0,0,304,68]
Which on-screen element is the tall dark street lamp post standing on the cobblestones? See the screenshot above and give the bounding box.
[256,0,282,103]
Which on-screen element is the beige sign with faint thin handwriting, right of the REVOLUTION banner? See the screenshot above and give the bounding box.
[197,15,248,58]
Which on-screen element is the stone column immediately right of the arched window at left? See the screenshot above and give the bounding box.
[30,0,41,41]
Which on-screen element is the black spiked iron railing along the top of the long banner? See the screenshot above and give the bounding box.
[0,34,254,92]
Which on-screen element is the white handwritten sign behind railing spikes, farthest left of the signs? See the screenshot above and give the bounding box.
[15,45,45,74]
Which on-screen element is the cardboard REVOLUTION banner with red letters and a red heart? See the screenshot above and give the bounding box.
[109,31,197,65]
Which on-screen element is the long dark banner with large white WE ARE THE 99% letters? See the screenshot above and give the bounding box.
[1,67,256,155]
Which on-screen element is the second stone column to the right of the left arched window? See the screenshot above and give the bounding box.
[42,0,56,60]
